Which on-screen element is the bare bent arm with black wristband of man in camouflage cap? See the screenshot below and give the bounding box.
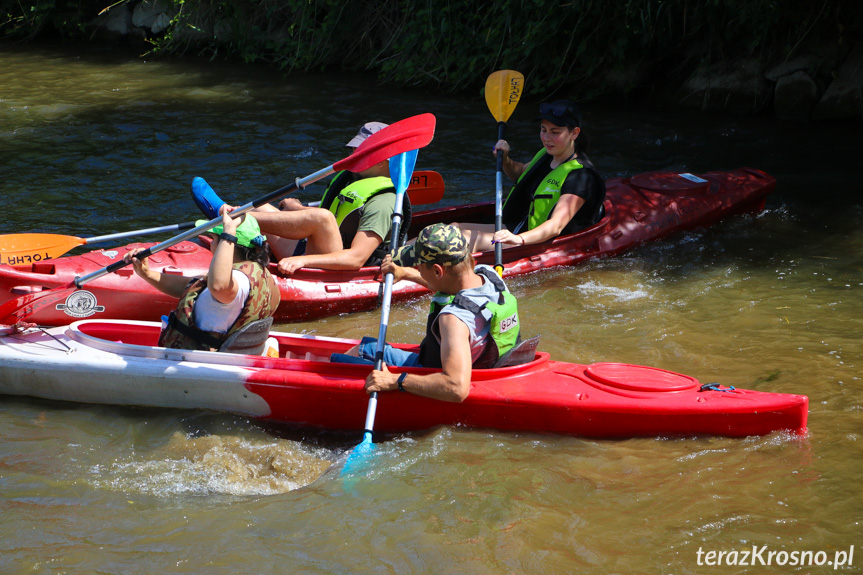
[366,314,472,403]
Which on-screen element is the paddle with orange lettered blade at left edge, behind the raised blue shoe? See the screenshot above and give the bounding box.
[0,171,444,266]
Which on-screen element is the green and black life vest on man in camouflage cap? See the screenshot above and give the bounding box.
[419,267,521,369]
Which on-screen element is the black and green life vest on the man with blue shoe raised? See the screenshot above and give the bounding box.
[321,171,411,266]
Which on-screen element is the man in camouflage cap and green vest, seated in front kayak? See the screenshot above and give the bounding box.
[332,224,520,402]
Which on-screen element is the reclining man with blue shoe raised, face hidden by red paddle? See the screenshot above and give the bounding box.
[192,122,410,275]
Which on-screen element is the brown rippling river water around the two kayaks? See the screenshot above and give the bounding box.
[0,46,863,574]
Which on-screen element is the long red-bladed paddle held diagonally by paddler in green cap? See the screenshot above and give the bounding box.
[0,114,435,324]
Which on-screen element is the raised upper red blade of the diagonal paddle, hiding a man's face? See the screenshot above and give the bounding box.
[333,114,435,172]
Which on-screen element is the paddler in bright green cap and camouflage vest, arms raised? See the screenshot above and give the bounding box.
[124,212,279,351]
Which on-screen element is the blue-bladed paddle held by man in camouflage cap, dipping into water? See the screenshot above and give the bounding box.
[342,150,417,475]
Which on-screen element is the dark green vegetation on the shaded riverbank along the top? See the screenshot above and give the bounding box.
[5,0,863,118]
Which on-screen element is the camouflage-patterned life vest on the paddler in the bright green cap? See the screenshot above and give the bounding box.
[158,262,279,351]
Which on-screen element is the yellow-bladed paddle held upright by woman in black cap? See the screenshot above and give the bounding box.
[485,70,524,275]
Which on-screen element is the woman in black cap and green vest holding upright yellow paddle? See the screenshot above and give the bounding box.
[456,99,605,252]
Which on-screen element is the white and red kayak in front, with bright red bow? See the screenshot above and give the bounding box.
[0,319,809,438]
